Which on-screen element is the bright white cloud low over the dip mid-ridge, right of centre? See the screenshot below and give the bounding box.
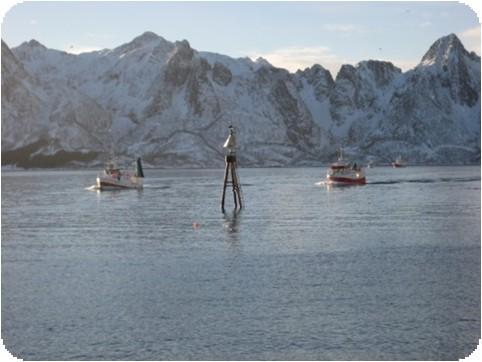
[250,46,351,76]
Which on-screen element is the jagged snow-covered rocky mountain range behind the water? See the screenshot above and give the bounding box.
[2,32,480,167]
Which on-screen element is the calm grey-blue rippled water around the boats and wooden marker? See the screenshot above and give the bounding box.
[2,167,481,360]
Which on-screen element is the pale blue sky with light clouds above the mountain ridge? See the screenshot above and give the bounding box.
[0,0,481,75]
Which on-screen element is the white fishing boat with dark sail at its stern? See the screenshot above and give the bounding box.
[96,158,144,190]
